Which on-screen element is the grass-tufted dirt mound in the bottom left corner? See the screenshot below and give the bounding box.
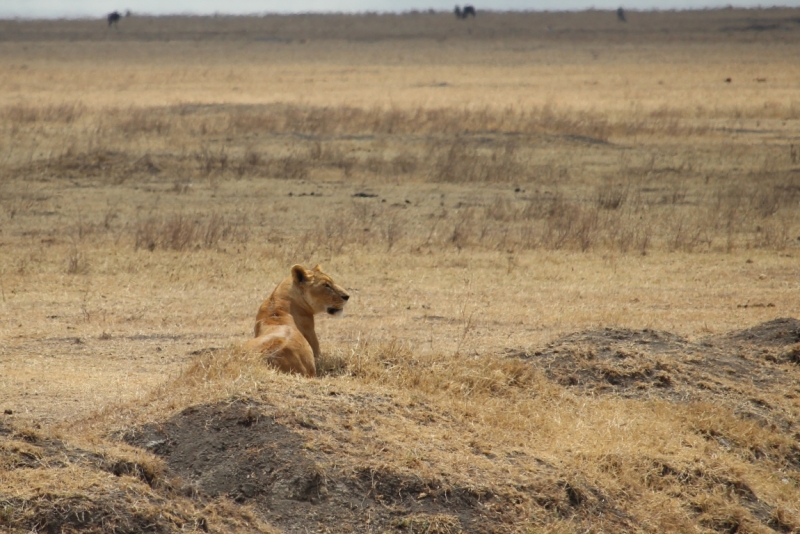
[0,426,247,534]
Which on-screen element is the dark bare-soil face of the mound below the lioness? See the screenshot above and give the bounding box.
[122,400,500,532]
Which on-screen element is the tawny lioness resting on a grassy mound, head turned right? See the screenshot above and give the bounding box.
[244,265,350,376]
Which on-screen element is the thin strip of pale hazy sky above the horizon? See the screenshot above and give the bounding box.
[0,0,800,18]
